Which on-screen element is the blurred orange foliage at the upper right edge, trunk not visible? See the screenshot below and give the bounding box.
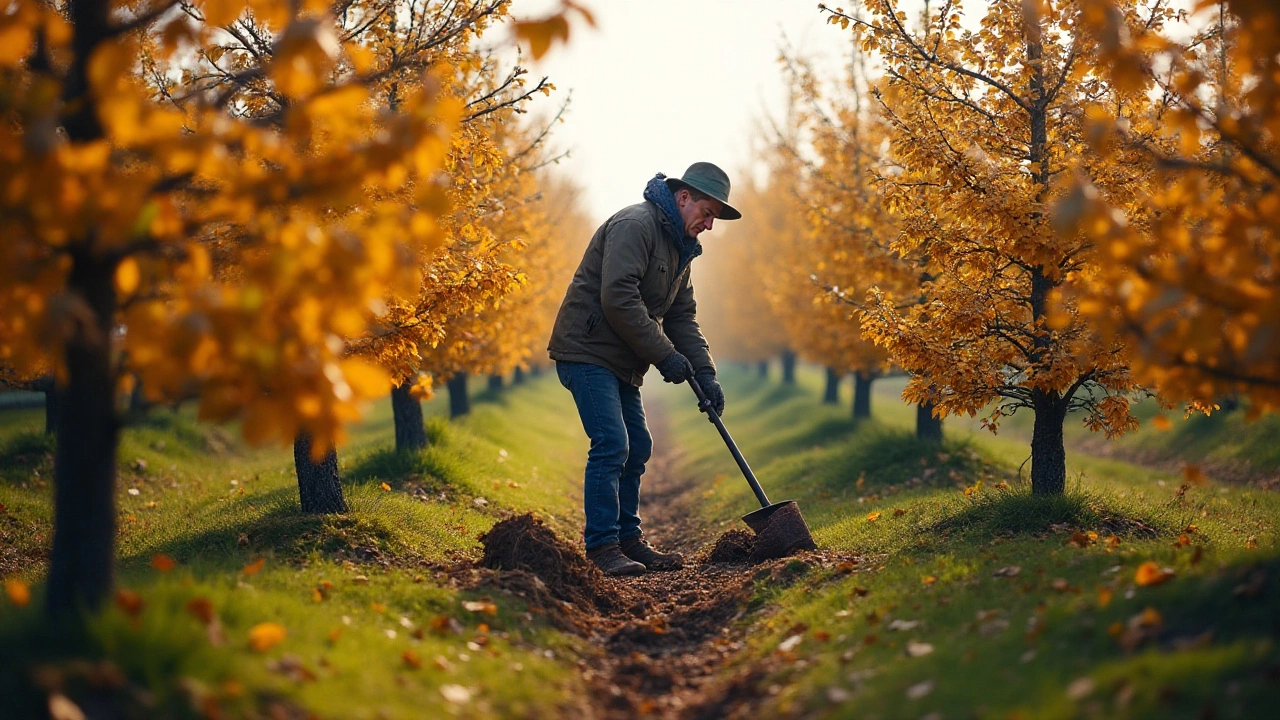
[1056,0,1280,414]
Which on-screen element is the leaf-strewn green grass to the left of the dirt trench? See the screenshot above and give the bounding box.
[0,380,585,717]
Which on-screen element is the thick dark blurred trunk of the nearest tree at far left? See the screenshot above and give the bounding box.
[46,251,120,617]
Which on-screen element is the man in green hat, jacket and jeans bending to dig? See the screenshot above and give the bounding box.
[548,163,742,575]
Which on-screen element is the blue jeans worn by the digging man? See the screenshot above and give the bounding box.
[556,363,653,550]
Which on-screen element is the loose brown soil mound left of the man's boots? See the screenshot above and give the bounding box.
[480,512,622,611]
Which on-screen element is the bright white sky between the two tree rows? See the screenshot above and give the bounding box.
[512,0,852,222]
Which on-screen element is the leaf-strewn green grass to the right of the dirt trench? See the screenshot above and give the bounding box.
[659,370,1280,719]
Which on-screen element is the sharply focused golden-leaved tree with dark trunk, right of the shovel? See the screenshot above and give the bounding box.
[832,0,1164,495]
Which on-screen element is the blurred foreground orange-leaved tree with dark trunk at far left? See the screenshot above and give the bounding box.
[0,0,462,618]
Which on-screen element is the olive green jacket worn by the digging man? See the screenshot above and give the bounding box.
[548,201,716,387]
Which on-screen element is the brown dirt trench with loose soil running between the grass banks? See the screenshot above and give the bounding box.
[481,404,845,720]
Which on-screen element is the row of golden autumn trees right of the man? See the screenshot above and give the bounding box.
[706,0,1280,493]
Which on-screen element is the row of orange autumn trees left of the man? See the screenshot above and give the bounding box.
[0,0,581,620]
